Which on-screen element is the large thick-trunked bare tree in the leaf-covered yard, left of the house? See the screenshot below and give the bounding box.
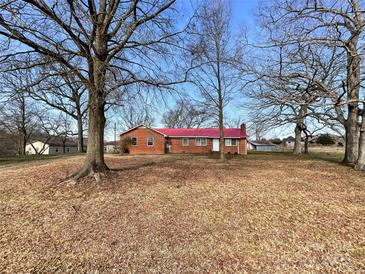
[0,0,182,181]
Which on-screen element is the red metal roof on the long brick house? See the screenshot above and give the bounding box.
[154,128,247,138]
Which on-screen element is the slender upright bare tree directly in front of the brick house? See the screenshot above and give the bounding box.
[190,0,242,161]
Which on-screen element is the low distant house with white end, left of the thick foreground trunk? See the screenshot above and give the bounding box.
[25,137,77,155]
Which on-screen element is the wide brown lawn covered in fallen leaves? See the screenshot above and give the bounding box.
[0,153,365,273]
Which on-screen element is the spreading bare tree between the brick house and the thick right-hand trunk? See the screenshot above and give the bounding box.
[247,42,337,154]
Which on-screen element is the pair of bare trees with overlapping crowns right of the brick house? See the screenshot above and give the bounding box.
[247,0,365,170]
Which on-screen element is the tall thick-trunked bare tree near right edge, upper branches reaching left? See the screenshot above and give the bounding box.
[262,0,365,164]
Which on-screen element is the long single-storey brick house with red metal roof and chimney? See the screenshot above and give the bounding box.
[120,124,247,155]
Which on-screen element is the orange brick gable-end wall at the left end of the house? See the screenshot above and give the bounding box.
[120,127,165,154]
